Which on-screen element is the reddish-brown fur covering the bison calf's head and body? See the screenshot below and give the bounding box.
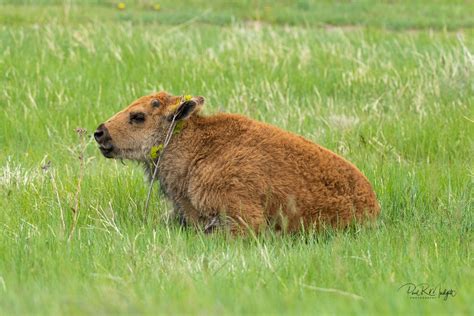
[94,92,380,232]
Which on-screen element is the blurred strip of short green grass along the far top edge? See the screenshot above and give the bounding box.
[0,0,474,30]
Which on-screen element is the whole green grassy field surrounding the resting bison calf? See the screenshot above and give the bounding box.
[0,0,474,315]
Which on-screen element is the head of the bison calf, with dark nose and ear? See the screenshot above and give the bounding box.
[94,92,204,161]
